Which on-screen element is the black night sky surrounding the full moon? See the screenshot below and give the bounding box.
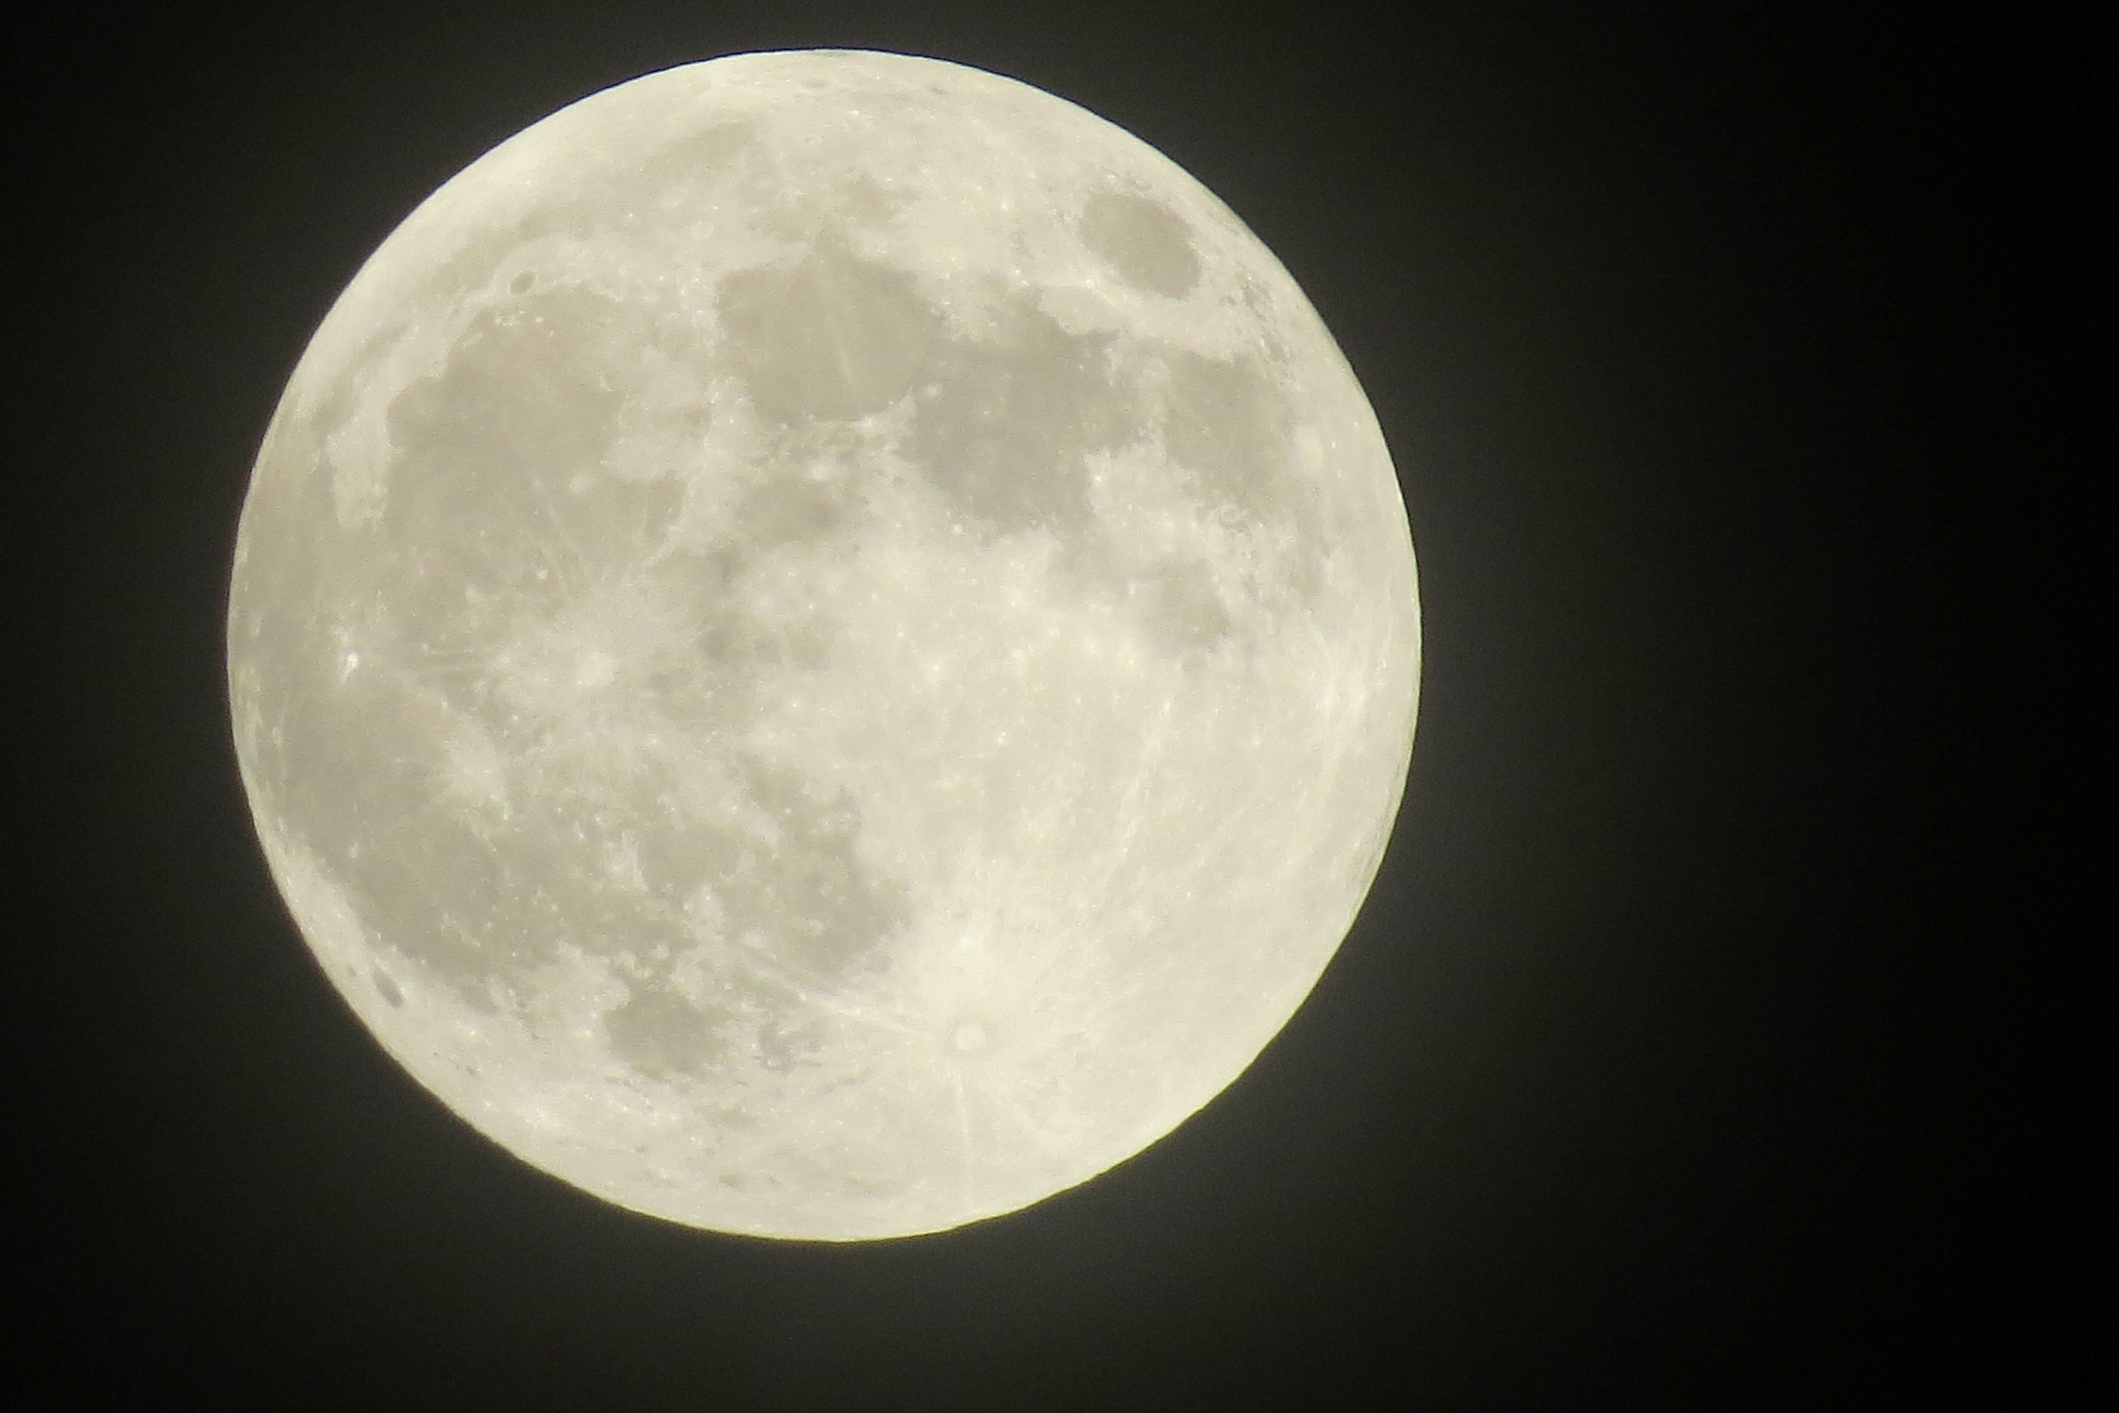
[16,0,2072,1409]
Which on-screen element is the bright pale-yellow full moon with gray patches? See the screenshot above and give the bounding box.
[227,51,1420,1241]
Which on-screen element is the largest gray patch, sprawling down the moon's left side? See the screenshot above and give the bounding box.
[240,265,905,1016]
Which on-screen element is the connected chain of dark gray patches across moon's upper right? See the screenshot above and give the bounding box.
[720,236,1301,650]
